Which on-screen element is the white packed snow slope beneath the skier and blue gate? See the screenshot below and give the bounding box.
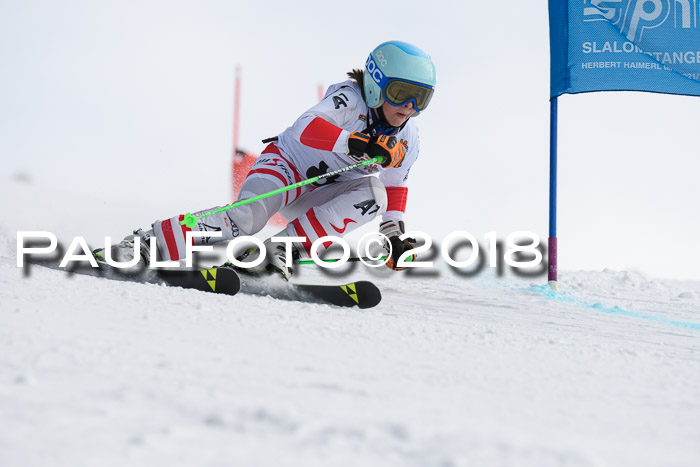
[0,180,700,467]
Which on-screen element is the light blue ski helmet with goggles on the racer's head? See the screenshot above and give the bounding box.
[364,41,436,113]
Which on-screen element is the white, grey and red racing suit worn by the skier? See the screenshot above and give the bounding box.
[154,81,419,260]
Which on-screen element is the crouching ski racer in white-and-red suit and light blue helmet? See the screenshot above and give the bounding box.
[95,41,436,279]
